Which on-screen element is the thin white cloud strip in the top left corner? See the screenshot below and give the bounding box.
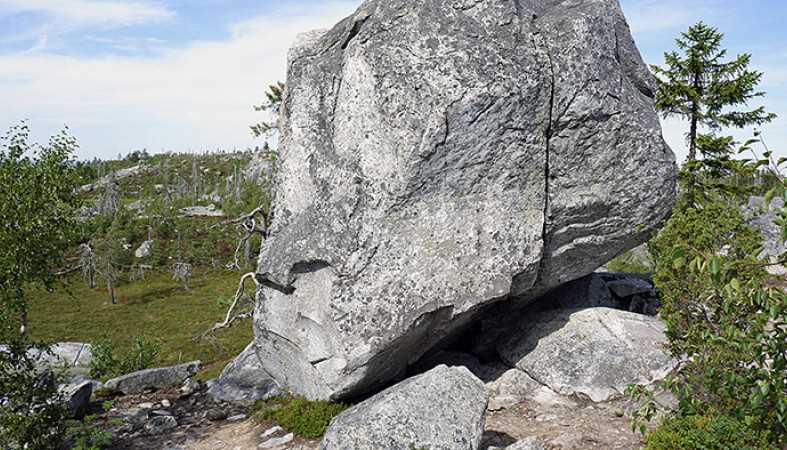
[0,0,175,27]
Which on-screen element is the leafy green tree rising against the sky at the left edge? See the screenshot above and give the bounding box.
[0,123,80,333]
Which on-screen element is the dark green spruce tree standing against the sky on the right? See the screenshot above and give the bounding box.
[652,22,776,161]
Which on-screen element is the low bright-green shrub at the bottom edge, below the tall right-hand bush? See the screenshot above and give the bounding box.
[645,415,773,450]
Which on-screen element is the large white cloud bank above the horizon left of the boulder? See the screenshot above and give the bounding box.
[0,1,358,157]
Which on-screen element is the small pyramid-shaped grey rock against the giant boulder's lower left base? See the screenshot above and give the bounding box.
[208,343,281,402]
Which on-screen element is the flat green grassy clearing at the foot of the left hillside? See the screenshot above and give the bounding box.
[30,269,252,378]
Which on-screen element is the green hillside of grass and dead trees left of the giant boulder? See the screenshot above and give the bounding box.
[29,150,273,378]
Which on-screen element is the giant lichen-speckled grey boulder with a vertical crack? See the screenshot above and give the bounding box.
[255,0,675,398]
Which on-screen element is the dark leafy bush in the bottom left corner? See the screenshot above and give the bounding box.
[0,339,68,450]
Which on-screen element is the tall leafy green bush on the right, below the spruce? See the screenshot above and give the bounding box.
[651,198,787,442]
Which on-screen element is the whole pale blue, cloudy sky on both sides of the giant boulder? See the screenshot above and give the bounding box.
[0,0,787,162]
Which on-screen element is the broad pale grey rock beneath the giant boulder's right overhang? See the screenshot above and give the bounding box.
[498,308,676,402]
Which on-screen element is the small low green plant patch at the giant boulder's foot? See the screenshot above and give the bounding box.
[254,397,347,438]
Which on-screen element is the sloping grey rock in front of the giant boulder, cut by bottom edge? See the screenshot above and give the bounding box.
[321,366,487,450]
